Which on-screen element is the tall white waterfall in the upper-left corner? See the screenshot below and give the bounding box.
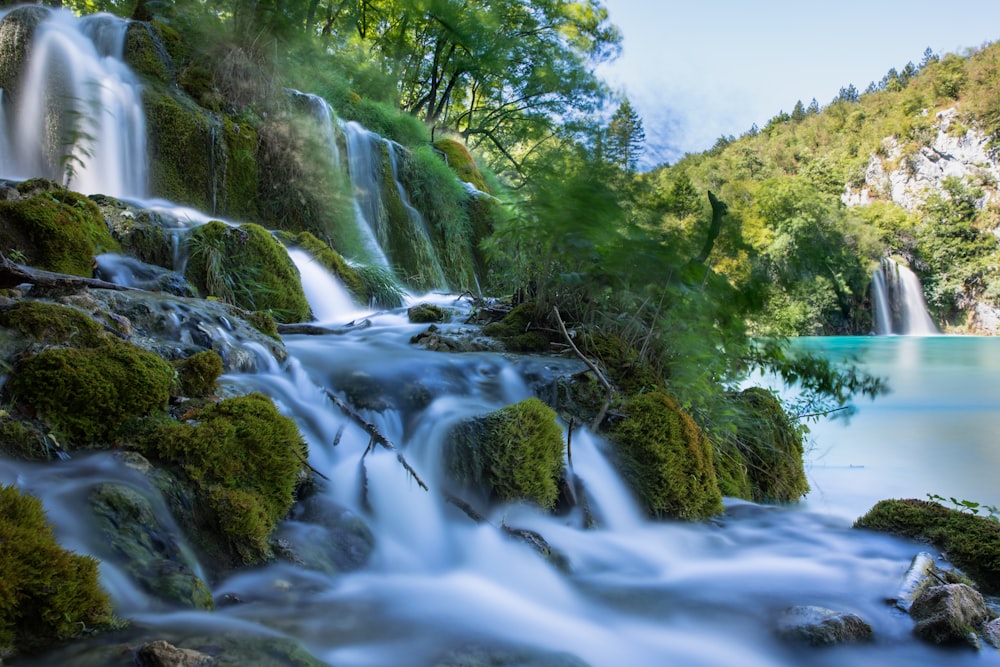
[0,10,148,197]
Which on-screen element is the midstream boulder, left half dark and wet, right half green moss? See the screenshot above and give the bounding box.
[445,398,565,510]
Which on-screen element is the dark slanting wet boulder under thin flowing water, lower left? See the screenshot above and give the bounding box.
[88,483,215,609]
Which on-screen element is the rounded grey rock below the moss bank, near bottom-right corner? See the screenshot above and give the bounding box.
[910,584,989,647]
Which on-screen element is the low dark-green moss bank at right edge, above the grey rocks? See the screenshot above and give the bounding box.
[854,499,1000,595]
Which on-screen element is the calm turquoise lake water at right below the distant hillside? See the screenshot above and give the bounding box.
[795,336,1000,516]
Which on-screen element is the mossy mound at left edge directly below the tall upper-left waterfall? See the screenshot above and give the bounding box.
[0,189,118,278]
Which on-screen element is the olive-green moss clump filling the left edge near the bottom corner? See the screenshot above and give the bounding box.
[0,486,121,655]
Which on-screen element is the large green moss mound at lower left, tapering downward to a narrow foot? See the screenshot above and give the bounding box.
[145,394,306,564]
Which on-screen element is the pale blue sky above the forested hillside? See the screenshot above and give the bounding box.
[598,0,1000,168]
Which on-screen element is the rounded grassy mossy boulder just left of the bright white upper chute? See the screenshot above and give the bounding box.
[184,220,310,323]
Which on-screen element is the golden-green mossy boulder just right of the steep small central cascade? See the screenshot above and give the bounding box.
[609,392,722,520]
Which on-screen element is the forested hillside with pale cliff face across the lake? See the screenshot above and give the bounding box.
[643,44,1000,334]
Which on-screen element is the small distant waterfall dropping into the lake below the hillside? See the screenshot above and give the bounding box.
[872,258,939,336]
